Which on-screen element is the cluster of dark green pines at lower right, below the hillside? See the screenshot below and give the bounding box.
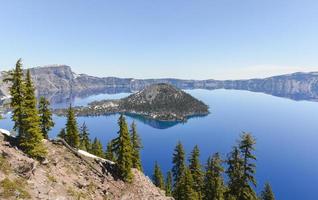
[153,133,275,200]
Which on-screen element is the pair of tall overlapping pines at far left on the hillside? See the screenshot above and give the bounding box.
[6,59,47,159]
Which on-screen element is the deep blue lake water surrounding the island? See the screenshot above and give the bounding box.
[0,90,318,200]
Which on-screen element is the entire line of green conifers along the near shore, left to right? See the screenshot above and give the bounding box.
[5,59,275,200]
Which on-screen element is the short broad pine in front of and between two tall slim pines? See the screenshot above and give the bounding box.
[173,167,199,200]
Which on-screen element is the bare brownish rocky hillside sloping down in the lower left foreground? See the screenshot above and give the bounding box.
[0,133,171,200]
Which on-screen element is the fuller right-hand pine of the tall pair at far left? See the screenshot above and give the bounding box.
[19,70,47,159]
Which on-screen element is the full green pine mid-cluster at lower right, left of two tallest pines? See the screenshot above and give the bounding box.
[203,153,225,200]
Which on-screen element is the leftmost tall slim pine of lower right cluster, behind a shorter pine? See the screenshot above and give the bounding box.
[172,141,186,185]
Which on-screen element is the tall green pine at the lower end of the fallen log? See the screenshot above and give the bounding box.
[113,115,133,182]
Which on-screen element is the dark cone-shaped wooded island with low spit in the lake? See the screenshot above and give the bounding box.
[54,83,209,121]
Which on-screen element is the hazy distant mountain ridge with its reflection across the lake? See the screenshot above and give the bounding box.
[0,65,318,101]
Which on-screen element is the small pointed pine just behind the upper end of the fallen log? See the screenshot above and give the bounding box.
[65,105,80,148]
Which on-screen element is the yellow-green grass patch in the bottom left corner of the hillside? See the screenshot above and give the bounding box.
[0,178,31,199]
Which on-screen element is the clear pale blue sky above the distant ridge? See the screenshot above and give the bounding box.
[0,0,318,79]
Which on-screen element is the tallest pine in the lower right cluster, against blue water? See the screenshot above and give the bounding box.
[239,133,257,200]
